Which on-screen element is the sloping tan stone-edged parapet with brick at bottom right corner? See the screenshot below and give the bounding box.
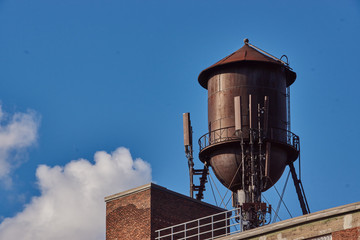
[218,202,360,240]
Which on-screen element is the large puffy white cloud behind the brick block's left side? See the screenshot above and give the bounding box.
[0,148,151,240]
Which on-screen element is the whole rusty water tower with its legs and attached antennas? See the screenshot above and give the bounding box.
[184,39,309,229]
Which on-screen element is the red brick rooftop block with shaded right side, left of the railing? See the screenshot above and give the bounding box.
[106,184,222,240]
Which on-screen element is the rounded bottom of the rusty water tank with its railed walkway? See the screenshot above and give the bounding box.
[199,126,300,191]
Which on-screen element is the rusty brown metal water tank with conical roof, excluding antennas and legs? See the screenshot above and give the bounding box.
[198,42,299,192]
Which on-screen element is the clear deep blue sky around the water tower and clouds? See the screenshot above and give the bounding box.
[0,0,360,239]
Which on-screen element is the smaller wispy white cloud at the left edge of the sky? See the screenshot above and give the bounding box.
[0,104,39,186]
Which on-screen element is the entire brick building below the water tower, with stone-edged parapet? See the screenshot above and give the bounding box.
[105,183,360,240]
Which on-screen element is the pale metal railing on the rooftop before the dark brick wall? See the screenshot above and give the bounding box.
[155,208,243,240]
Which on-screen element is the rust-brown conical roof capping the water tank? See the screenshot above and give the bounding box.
[198,41,296,89]
